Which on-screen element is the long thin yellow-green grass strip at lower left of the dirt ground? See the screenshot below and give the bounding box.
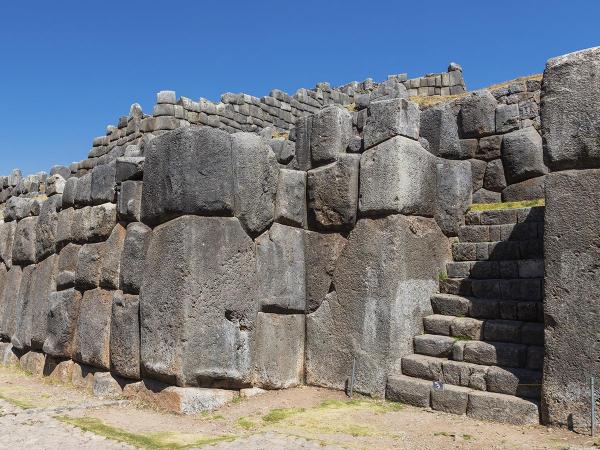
[54,416,236,449]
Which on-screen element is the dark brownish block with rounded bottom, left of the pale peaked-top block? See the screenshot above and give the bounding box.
[307,154,361,230]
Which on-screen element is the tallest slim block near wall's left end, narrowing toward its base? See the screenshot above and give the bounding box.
[31,255,58,350]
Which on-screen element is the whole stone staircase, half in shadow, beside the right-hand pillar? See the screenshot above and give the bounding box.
[386,207,544,424]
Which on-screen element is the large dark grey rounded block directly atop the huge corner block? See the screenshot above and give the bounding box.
[142,127,233,224]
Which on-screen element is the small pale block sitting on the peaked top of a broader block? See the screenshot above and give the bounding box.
[363,98,420,149]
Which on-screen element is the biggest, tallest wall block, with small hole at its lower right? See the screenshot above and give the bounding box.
[140,217,258,387]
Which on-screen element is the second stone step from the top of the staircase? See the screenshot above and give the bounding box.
[458,222,544,242]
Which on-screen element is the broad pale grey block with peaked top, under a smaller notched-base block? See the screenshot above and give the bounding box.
[359,136,436,217]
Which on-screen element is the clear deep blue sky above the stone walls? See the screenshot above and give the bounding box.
[0,0,600,174]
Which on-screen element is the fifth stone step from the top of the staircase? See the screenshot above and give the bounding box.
[440,278,543,302]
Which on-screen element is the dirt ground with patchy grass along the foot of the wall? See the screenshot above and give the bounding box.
[0,368,600,449]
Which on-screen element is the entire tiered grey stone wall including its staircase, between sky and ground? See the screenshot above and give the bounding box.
[0,48,600,428]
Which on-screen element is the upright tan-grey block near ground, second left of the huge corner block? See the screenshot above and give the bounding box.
[73,289,112,370]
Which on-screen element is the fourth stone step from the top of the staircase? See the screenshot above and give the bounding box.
[446,259,544,279]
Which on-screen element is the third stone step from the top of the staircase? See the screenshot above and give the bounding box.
[452,239,544,261]
